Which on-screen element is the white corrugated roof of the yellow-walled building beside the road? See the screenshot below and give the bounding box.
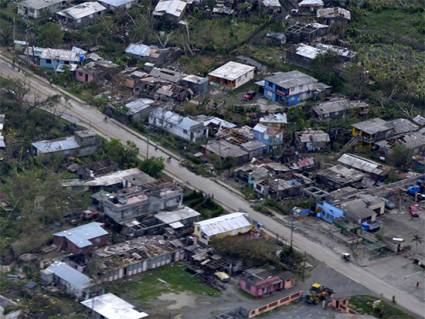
[195,213,252,236]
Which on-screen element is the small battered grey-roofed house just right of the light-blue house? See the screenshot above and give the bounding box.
[295,129,331,152]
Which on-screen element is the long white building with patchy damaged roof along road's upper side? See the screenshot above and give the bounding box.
[149,107,208,143]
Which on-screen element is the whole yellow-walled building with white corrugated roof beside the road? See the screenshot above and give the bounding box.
[193,213,253,245]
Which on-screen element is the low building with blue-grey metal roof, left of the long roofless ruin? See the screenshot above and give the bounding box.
[41,261,93,298]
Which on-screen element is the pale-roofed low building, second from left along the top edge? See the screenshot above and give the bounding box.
[56,1,106,27]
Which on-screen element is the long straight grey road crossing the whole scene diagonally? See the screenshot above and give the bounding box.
[0,56,425,318]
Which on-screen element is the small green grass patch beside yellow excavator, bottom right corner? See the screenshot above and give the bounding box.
[349,295,414,319]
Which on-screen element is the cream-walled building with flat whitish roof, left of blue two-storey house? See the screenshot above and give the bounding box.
[208,61,255,89]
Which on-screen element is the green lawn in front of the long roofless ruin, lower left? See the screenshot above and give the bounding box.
[108,263,220,306]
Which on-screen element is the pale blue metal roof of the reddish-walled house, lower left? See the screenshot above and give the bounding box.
[54,222,108,248]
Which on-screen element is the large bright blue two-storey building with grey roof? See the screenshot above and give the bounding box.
[264,71,330,106]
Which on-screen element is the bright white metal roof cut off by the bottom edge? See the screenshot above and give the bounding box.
[81,293,148,319]
